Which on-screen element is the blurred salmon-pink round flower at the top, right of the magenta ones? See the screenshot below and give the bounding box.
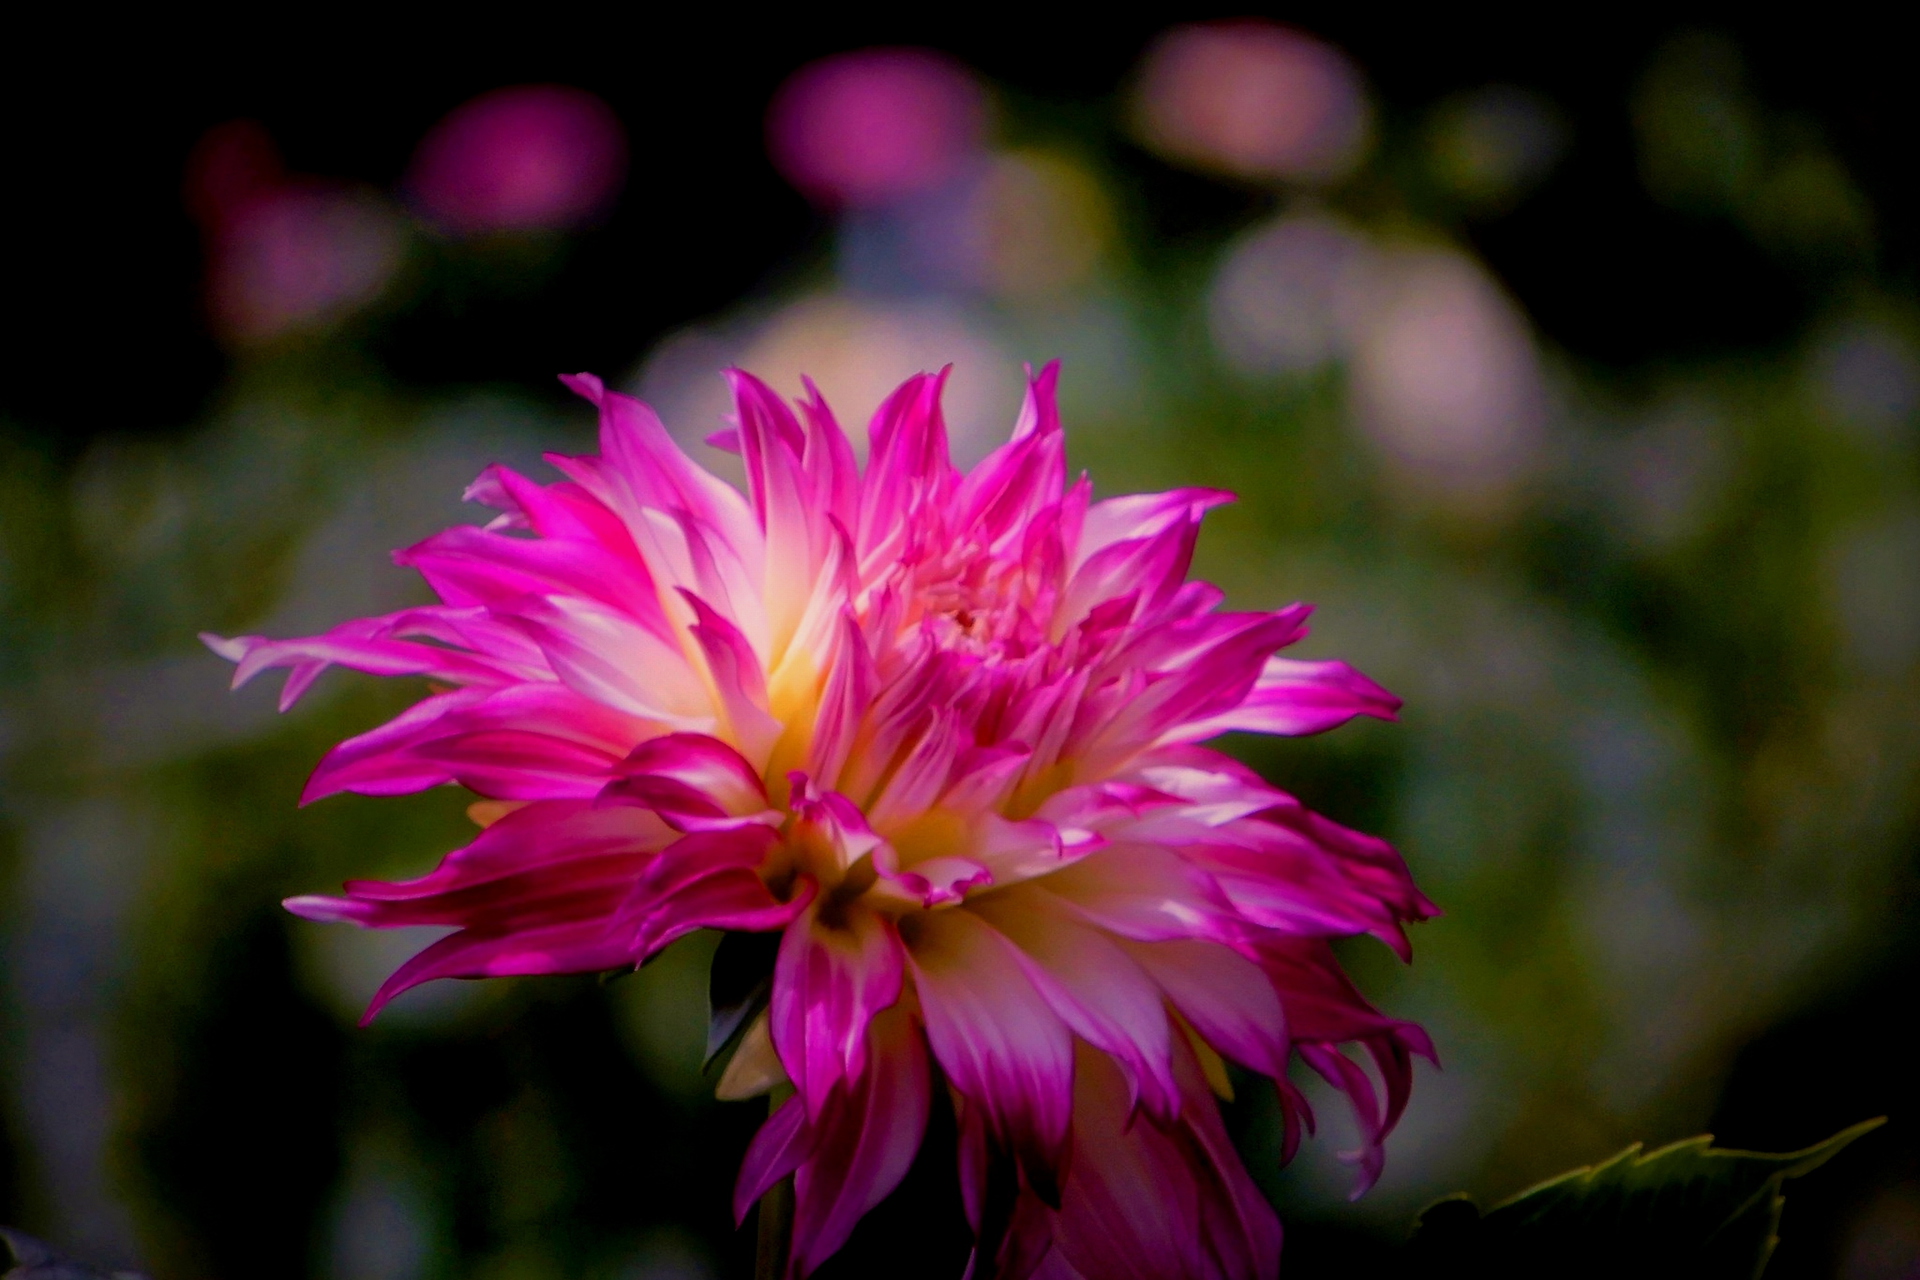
[1133,21,1373,182]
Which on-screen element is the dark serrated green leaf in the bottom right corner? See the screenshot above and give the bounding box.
[1413,1117,1885,1280]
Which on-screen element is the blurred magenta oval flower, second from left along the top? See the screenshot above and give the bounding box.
[405,84,626,236]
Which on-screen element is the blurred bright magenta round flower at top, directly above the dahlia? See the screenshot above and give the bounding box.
[766,48,987,205]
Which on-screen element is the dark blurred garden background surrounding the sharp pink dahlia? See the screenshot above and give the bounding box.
[0,6,1920,1280]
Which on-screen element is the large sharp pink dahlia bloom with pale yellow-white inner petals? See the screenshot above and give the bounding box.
[207,367,1434,1280]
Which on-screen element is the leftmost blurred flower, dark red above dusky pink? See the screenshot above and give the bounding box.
[186,121,405,344]
